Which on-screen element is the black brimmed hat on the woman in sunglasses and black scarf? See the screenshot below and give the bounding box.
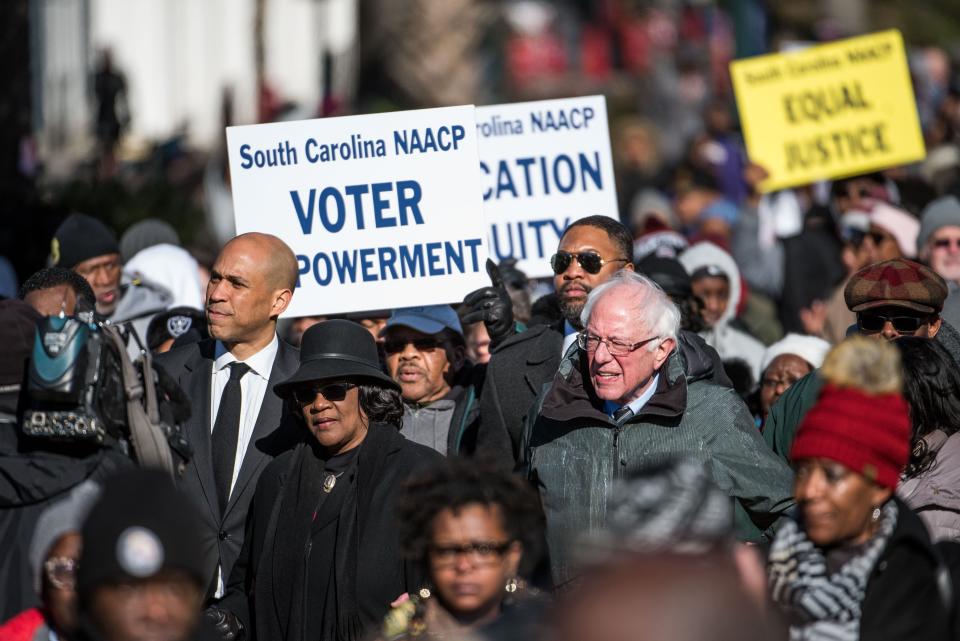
[273,319,400,398]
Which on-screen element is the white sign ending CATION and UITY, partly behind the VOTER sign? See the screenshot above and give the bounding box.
[477,96,618,278]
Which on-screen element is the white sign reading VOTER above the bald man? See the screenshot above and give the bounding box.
[227,106,489,316]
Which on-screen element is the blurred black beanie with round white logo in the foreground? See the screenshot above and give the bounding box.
[77,468,210,598]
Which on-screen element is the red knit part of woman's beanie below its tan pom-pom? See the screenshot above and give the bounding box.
[790,383,910,489]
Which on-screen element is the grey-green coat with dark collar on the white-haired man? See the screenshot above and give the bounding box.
[521,342,793,587]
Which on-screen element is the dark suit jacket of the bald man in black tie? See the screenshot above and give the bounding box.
[157,339,303,582]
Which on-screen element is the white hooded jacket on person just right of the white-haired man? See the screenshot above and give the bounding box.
[679,242,764,381]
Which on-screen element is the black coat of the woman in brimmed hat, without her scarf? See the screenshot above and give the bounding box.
[220,424,443,641]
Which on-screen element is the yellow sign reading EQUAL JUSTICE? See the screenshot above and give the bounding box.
[730,30,926,191]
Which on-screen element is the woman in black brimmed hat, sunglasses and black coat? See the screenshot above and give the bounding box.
[209,320,441,641]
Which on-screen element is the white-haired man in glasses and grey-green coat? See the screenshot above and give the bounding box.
[521,271,792,588]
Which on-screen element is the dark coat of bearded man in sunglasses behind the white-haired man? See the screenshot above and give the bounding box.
[476,304,733,470]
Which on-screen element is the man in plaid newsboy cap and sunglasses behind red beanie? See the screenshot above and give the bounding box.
[763,258,960,460]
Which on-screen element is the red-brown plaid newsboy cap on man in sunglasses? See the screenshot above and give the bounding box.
[843,258,947,314]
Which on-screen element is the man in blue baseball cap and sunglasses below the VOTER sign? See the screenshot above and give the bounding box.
[381,305,483,455]
